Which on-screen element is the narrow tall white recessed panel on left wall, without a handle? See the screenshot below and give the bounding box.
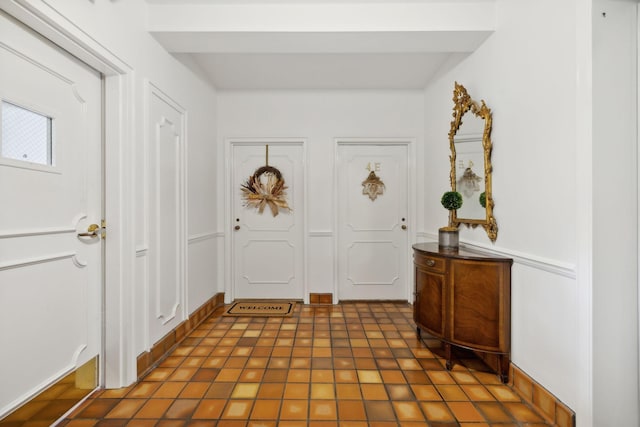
[147,88,186,344]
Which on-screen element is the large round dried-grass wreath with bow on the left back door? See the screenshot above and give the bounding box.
[240,166,291,217]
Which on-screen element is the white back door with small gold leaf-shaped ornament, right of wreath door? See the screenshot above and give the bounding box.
[337,144,409,300]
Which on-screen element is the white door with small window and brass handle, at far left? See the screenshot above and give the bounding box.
[0,13,102,416]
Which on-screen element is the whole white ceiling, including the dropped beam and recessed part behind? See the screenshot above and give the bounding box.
[147,0,495,90]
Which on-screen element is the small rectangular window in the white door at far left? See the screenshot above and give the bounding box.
[0,101,54,166]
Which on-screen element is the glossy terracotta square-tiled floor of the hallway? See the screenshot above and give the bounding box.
[59,302,550,427]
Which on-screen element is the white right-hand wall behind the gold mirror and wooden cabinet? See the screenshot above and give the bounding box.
[425,0,578,418]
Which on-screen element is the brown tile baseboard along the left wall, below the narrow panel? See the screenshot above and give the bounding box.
[137,292,224,379]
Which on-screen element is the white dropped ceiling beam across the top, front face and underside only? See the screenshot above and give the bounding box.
[148,1,495,53]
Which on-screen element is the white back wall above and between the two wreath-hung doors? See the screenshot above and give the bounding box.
[217,91,424,293]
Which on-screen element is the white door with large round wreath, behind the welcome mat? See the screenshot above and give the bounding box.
[231,142,304,299]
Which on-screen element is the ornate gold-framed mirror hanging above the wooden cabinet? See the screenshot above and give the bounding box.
[449,82,498,242]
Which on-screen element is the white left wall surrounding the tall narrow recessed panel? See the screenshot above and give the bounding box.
[56,1,217,360]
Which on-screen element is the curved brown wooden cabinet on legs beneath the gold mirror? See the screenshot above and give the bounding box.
[413,243,513,383]
